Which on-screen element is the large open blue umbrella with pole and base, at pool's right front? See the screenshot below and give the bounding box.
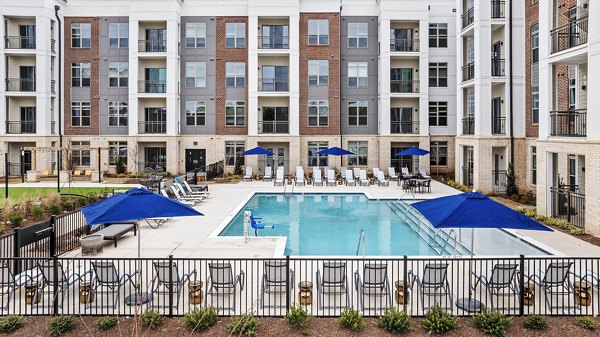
[412,192,553,312]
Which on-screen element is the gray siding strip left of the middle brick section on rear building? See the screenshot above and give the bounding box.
[180,16,217,135]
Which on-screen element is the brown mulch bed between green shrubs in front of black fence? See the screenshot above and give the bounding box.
[5,317,598,337]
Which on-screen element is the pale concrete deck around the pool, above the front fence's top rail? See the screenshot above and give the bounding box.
[58,181,600,258]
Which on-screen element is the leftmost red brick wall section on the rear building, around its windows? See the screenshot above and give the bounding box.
[63,17,100,136]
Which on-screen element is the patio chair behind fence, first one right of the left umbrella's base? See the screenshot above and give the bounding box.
[150,261,196,308]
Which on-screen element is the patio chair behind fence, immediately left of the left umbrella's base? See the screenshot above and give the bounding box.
[86,261,139,309]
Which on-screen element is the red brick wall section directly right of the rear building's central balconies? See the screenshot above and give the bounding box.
[299,13,340,135]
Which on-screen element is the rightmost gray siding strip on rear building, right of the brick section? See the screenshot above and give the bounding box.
[340,16,379,135]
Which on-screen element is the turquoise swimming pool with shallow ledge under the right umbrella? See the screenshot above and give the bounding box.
[219,193,543,256]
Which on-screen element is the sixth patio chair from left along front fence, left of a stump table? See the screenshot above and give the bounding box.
[260,261,294,308]
